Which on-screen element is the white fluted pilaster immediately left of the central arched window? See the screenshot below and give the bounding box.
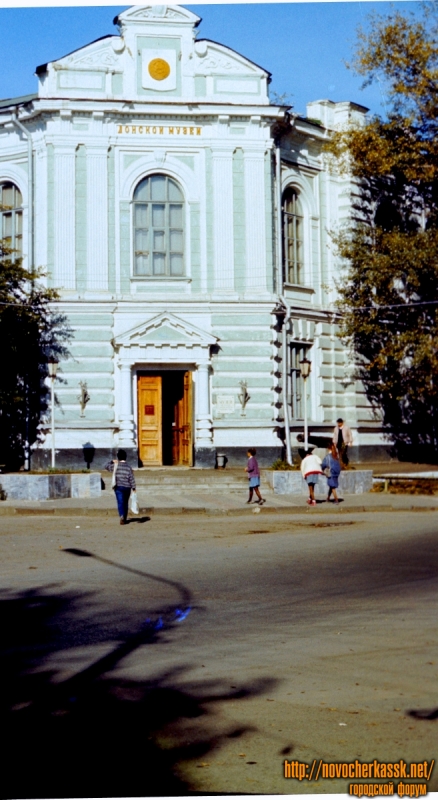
[87,146,108,292]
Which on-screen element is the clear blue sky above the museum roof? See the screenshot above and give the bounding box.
[0,0,421,113]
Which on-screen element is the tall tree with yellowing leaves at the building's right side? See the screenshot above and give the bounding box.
[328,6,438,460]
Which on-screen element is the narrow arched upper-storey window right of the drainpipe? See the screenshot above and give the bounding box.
[283,188,304,284]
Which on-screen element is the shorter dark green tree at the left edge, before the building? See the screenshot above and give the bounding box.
[0,239,71,469]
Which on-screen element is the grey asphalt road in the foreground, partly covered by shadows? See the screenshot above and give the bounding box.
[0,509,438,798]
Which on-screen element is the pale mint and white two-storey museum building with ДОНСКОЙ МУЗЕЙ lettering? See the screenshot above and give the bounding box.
[0,6,383,467]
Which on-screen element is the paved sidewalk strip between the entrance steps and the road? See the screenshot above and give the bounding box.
[0,486,438,517]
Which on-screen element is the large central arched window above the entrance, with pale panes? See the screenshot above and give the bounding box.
[133,175,184,277]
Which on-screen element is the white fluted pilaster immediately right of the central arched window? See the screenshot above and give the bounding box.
[213,150,234,292]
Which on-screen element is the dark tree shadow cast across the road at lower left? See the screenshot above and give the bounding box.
[0,551,272,798]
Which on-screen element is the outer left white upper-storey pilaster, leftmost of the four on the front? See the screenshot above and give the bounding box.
[53,145,76,289]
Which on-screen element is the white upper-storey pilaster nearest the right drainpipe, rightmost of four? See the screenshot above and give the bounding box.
[244,151,267,292]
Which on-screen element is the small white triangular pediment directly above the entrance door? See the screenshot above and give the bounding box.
[115,312,217,347]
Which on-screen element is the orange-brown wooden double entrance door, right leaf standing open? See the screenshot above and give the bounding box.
[138,370,193,467]
